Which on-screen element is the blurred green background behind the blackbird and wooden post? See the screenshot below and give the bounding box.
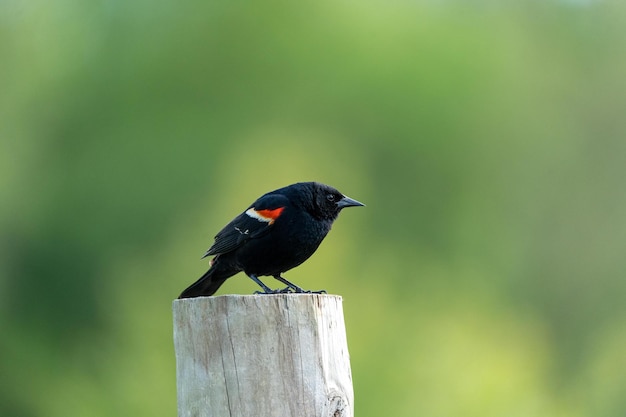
[0,0,626,417]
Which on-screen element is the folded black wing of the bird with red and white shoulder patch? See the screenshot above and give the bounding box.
[203,194,289,258]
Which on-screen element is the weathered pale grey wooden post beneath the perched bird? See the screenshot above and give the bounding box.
[173,294,354,417]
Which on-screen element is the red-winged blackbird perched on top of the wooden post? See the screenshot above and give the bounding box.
[179,182,364,298]
